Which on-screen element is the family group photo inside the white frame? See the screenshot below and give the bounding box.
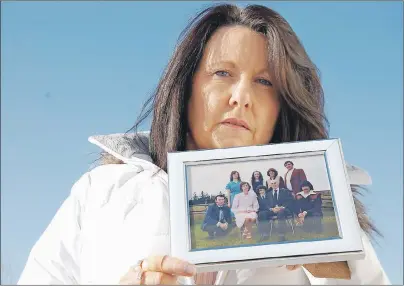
[186,154,339,250]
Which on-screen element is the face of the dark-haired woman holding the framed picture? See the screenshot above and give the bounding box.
[187,26,280,149]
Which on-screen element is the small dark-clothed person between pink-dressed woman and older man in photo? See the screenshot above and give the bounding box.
[257,186,275,240]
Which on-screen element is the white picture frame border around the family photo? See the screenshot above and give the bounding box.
[168,139,364,272]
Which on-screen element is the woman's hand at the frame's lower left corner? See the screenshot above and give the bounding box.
[119,255,196,285]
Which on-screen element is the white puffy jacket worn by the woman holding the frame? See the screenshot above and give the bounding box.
[18,135,390,285]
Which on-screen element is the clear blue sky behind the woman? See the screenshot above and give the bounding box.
[1,2,403,284]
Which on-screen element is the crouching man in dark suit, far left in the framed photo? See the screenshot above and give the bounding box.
[202,195,231,239]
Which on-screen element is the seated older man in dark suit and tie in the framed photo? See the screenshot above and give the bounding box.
[268,180,294,241]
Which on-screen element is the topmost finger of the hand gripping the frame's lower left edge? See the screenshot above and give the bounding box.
[142,256,196,276]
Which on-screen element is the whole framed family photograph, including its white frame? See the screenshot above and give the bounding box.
[168,139,363,272]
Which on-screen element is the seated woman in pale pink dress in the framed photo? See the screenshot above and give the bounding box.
[232,182,259,239]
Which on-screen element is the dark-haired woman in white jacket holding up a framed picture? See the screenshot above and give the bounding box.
[19,2,389,285]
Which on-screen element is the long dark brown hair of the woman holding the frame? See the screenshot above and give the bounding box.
[131,4,328,171]
